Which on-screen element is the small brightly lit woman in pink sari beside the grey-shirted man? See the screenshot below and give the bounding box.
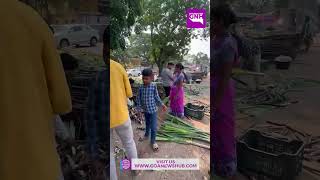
[170,63,185,118]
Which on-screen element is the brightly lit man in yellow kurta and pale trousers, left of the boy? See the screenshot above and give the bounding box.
[110,60,138,180]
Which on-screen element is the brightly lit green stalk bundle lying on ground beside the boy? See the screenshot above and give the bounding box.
[157,114,210,149]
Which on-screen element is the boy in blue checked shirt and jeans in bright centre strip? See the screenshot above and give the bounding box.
[137,69,167,151]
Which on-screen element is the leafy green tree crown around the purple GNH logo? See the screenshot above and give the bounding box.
[135,0,210,71]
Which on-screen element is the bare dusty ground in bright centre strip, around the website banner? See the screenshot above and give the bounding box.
[116,76,210,180]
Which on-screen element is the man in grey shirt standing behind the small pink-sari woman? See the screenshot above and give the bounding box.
[161,62,174,97]
